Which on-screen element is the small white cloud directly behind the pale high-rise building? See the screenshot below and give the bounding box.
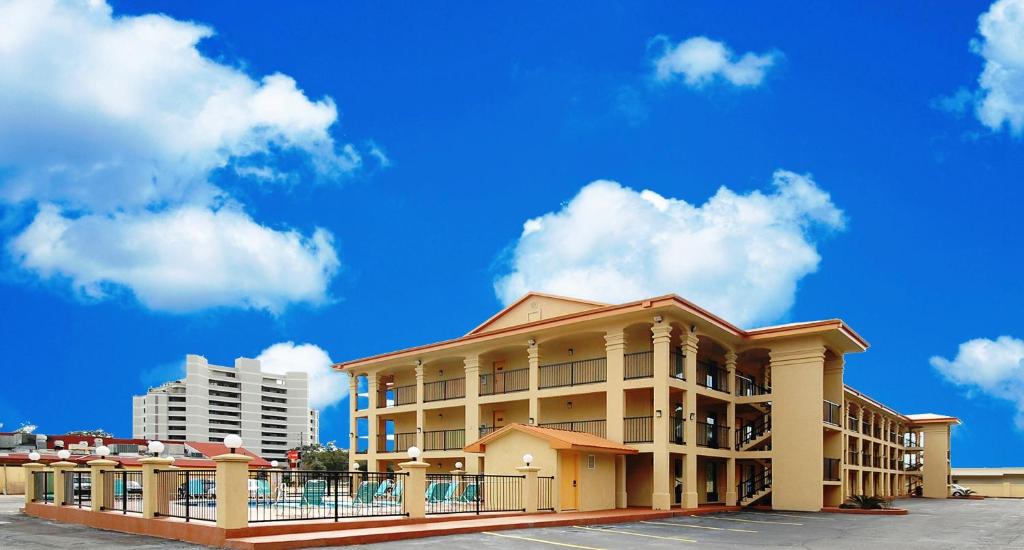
[256,342,348,411]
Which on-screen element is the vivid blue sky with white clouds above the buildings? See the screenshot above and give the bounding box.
[0,0,1024,466]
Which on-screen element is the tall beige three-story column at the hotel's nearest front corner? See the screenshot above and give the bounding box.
[650,318,672,510]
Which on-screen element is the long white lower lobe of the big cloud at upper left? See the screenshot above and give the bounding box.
[9,205,339,312]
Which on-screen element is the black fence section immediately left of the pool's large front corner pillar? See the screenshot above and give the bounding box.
[145,469,217,521]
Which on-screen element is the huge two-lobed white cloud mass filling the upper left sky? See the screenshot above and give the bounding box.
[0,0,362,310]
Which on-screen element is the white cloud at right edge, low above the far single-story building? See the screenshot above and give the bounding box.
[930,336,1024,430]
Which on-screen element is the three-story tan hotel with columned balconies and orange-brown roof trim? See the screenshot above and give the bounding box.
[335,293,958,511]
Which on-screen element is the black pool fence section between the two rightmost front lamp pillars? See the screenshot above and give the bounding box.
[425,473,525,514]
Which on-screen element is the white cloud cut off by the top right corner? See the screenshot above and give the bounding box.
[971,0,1024,136]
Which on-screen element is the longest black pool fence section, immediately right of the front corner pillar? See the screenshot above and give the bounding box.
[249,470,405,522]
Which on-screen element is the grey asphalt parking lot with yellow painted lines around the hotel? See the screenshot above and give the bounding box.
[0,497,1024,550]
